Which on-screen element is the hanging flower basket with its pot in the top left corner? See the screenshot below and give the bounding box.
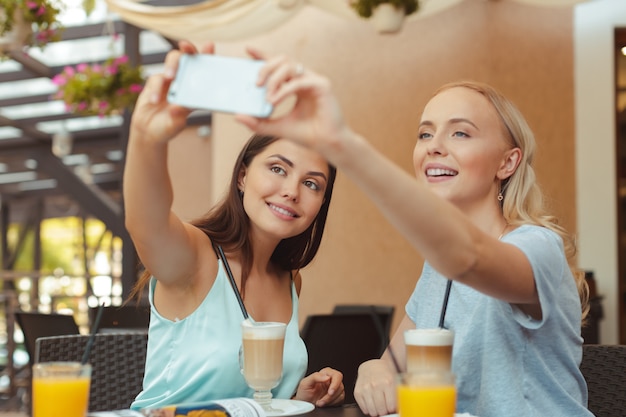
[0,0,63,51]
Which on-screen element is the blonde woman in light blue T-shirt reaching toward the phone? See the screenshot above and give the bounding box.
[238,51,591,417]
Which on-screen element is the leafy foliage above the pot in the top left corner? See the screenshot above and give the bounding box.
[0,0,63,48]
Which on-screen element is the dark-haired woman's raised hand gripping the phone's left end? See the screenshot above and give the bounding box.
[131,41,214,142]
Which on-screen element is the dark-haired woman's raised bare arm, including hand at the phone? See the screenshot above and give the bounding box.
[124,42,212,284]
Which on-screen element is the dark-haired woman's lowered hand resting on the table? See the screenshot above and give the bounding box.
[293,368,345,407]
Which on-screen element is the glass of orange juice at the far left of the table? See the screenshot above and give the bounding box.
[33,362,91,417]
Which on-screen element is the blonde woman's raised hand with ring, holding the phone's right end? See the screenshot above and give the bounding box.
[236,49,353,157]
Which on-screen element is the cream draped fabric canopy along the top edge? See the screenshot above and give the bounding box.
[106,0,596,42]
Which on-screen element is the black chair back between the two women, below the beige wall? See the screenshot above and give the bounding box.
[301,313,387,403]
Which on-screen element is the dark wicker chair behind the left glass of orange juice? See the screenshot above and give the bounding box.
[35,331,148,411]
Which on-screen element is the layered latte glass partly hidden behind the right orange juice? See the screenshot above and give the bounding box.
[404,328,454,372]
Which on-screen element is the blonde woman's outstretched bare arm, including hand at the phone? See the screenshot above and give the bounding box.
[238,56,538,304]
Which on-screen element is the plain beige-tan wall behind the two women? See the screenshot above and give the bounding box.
[167,0,576,334]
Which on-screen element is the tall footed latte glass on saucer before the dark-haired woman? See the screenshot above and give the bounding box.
[241,320,287,411]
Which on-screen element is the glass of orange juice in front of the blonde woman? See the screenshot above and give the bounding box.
[398,372,456,417]
